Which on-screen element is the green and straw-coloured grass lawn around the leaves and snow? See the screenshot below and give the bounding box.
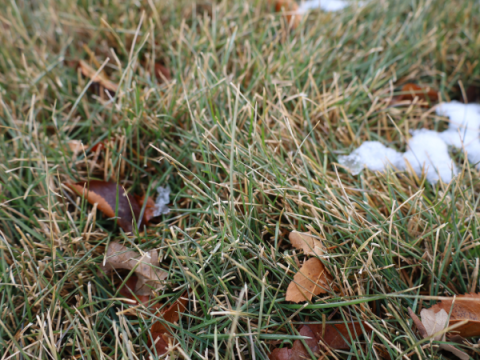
[0,0,480,360]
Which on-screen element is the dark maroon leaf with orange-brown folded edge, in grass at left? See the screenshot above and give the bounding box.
[65,180,140,233]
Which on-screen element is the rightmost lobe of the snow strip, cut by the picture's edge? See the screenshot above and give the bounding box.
[436,101,480,168]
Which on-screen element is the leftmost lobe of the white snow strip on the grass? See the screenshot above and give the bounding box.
[338,141,405,175]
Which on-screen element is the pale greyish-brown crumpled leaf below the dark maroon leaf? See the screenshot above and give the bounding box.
[101,241,168,296]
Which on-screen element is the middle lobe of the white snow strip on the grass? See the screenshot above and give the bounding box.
[403,129,458,184]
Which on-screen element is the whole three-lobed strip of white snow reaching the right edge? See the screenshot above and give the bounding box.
[339,101,480,184]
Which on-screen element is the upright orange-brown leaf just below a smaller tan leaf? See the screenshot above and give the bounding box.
[286,258,332,303]
